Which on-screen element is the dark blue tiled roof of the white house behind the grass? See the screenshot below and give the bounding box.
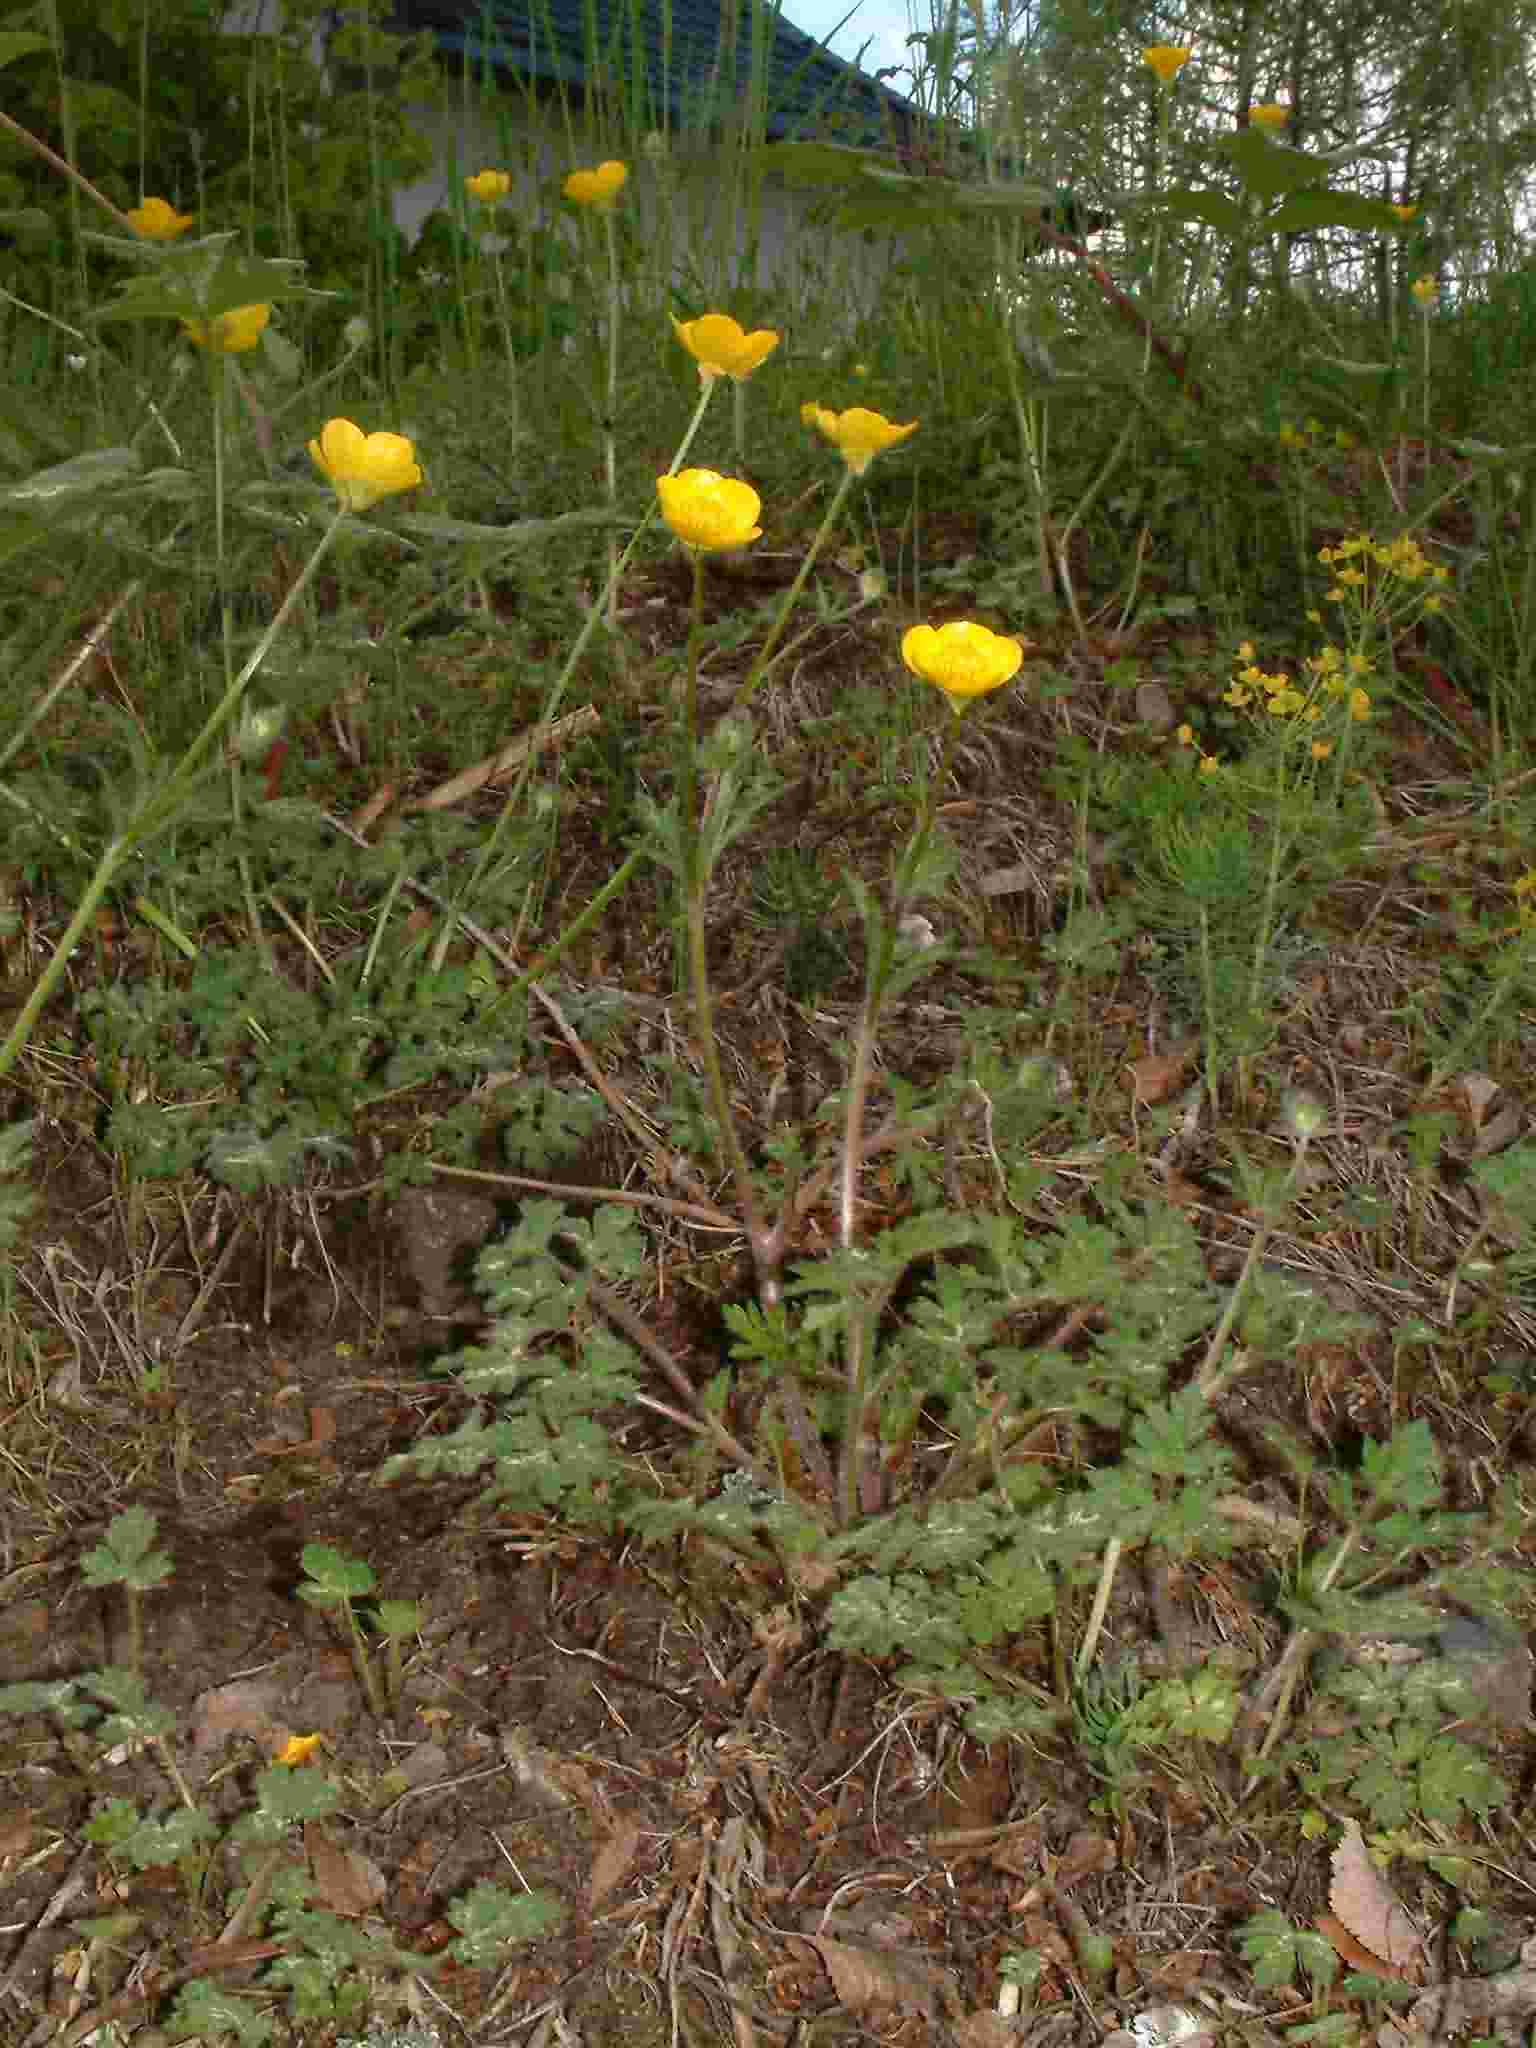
[389,0,915,147]
